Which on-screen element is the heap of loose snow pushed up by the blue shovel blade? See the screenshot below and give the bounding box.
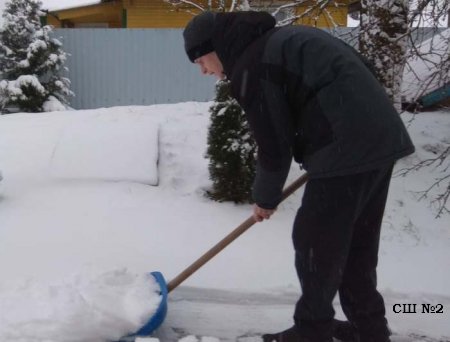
[0,269,161,342]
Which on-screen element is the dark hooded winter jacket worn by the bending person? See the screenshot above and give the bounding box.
[212,12,414,209]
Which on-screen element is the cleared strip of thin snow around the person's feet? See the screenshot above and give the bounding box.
[149,287,450,342]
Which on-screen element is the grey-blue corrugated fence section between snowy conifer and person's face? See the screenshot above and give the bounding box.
[54,29,215,109]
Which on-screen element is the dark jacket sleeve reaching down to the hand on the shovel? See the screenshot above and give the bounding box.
[232,71,294,209]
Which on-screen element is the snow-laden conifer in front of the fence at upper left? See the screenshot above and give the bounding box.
[0,0,73,112]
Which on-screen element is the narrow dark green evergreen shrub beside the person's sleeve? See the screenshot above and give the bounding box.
[206,81,256,203]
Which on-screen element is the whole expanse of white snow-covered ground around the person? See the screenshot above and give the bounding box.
[0,103,450,342]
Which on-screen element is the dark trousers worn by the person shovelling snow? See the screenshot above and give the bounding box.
[293,166,392,342]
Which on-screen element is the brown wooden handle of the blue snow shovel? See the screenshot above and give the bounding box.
[167,173,308,292]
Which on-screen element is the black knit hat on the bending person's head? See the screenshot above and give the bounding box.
[183,11,215,63]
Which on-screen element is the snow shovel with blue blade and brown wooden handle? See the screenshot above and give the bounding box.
[132,173,308,336]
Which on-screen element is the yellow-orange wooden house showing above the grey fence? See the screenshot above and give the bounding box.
[43,0,355,28]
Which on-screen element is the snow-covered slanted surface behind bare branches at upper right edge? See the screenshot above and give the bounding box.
[402,28,450,102]
